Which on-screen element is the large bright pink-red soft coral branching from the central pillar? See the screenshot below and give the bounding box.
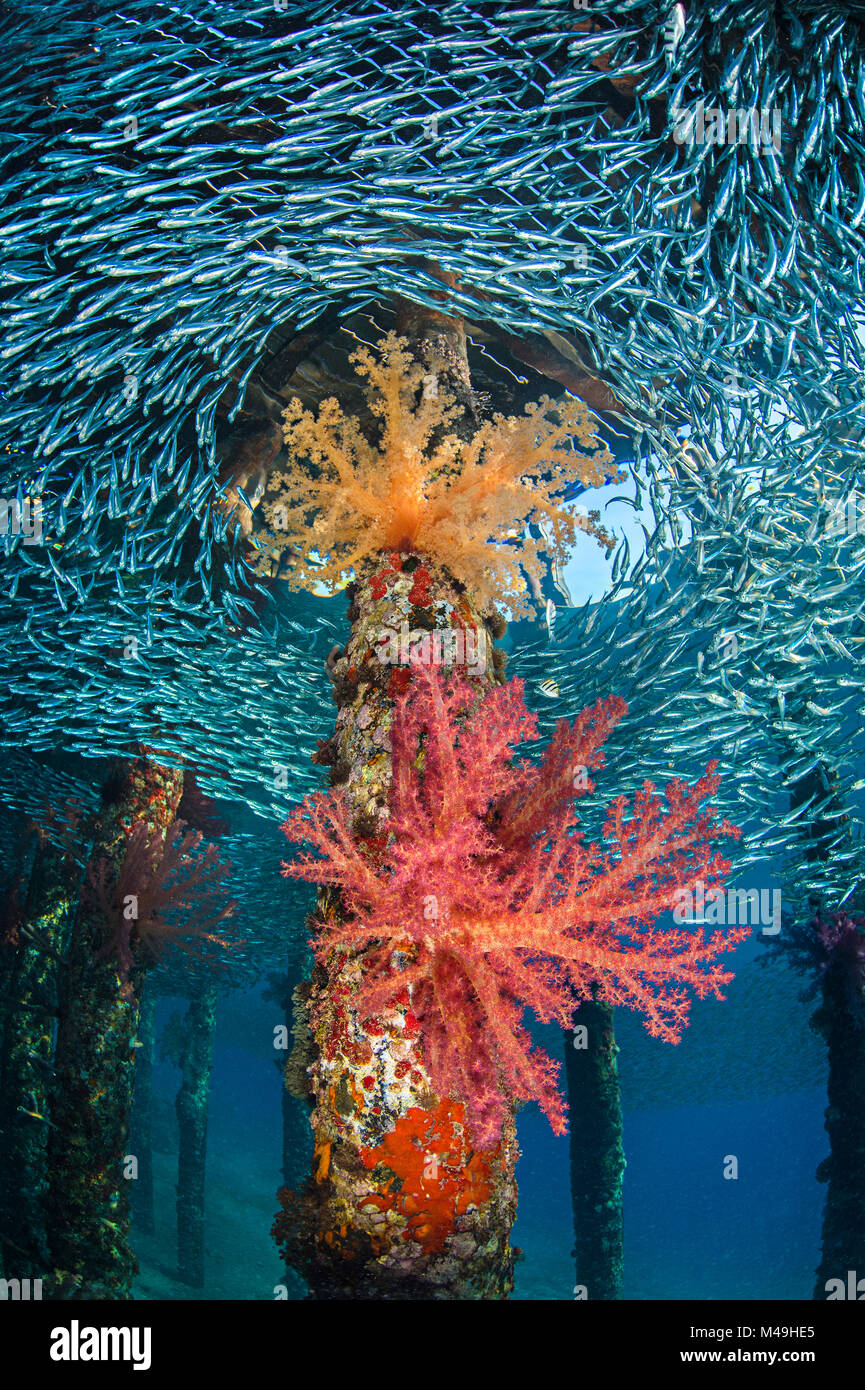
[282,667,747,1148]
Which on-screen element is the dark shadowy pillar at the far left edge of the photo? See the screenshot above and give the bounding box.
[0,838,81,1279]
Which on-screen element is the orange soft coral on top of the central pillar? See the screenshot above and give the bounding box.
[263,334,612,617]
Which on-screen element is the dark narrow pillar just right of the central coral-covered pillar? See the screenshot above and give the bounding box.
[565,999,624,1300]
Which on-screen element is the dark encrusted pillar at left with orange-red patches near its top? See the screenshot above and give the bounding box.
[46,758,184,1298]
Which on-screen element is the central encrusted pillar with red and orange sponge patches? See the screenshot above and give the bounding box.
[274,553,517,1300]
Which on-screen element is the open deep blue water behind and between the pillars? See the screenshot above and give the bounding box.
[136,967,827,1301]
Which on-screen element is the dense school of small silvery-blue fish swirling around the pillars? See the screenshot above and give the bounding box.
[0,0,865,934]
